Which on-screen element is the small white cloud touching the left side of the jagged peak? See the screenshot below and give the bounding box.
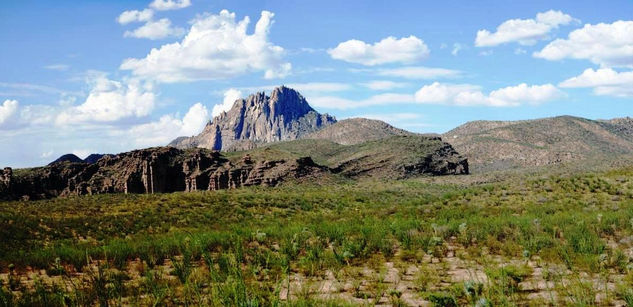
[126,103,209,146]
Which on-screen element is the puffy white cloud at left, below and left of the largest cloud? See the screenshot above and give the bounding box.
[56,77,155,125]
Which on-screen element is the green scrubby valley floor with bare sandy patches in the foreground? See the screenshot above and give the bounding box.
[0,167,633,306]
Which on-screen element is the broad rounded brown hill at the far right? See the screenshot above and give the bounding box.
[442,116,633,171]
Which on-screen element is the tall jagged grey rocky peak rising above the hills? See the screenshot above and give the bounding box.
[169,86,336,151]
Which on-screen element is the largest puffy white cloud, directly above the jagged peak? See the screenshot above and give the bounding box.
[120,10,291,82]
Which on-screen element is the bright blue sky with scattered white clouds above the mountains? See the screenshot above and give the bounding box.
[0,0,633,167]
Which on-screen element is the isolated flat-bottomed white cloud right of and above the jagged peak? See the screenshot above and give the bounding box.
[327,35,429,66]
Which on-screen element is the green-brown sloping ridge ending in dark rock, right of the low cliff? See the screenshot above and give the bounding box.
[235,135,468,179]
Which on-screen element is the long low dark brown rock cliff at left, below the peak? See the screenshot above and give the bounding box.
[0,147,327,199]
